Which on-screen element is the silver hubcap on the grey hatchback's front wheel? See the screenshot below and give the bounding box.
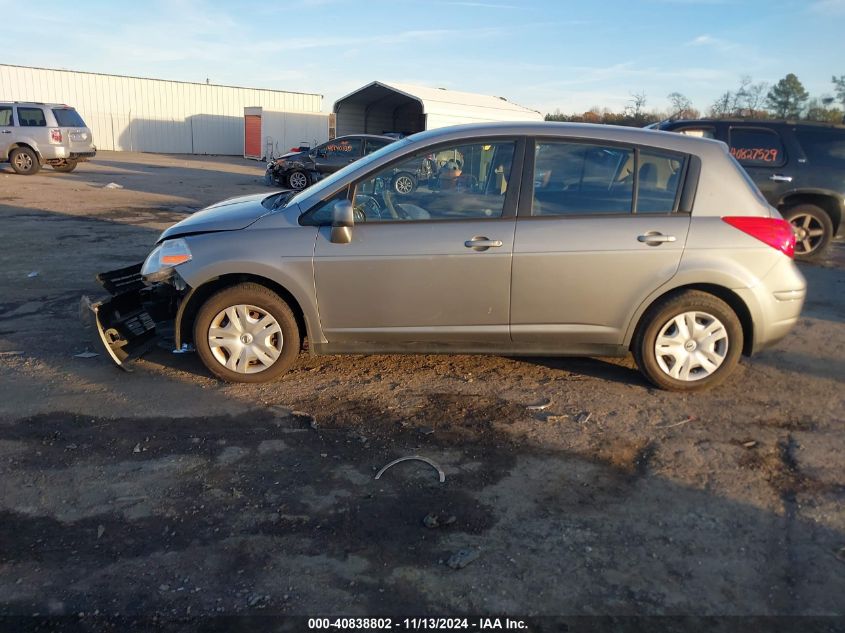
[208,305,284,374]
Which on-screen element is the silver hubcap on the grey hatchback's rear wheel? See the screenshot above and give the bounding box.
[654,312,728,382]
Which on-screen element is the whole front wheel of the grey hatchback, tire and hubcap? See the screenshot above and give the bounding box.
[194,283,301,383]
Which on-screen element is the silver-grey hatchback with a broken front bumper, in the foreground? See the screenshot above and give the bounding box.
[93,123,806,391]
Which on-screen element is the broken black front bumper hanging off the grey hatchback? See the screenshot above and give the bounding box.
[90,264,184,369]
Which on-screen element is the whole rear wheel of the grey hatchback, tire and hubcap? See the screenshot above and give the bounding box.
[631,290,743,392]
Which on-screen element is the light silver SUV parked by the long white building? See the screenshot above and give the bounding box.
[0,101,97,176]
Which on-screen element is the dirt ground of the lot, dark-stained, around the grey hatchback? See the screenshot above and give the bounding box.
[0,152,845,618]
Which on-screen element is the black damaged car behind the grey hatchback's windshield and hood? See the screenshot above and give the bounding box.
[264,134,396,191]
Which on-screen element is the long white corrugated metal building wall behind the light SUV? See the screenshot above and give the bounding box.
[0,64,323,155]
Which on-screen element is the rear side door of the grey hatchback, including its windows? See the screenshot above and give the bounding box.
[511,138,690,353]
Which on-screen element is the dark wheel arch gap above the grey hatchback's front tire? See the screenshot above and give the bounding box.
[174,273,309,349]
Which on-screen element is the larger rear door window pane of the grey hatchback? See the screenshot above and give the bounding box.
[532,141,634,216]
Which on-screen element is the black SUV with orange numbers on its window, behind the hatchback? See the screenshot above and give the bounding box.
[650,119,845,260]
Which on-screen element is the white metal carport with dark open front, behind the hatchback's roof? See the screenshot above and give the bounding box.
[334,81,543,136]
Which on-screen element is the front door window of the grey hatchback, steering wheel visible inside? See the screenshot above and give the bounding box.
[346,140,516,222]
